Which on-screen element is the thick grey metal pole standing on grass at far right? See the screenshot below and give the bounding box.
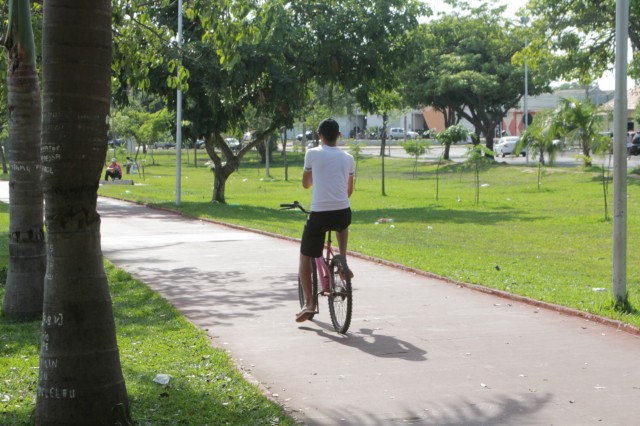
[613,0,629,303]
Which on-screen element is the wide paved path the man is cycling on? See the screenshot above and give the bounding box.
[0,182,640,425]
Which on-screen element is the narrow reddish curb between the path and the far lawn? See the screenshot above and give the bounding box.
[101,195,640,337]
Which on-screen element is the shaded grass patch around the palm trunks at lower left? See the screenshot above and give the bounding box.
[0,203,294,425]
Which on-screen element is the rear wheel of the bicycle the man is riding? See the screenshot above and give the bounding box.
[329,255,353,334]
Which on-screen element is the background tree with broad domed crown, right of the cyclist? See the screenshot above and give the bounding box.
[409,2,549,150]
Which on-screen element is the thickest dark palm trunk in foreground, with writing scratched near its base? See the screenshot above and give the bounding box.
[35,0,129,425]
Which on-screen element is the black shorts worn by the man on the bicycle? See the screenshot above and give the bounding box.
[300,208,351,257]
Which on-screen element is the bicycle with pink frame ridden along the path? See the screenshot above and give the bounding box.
[280,201,353,334]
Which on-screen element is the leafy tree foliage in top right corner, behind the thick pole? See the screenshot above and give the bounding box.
[523,0,640,84]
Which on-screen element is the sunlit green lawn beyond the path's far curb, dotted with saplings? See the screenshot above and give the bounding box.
[100,151,640,326]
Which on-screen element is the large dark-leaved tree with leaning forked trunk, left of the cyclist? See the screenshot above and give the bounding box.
[114,0,423,202]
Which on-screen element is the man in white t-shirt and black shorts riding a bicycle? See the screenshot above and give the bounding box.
[296,118,355,322]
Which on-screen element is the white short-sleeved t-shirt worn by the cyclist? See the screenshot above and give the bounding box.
[304,145,355,212]
